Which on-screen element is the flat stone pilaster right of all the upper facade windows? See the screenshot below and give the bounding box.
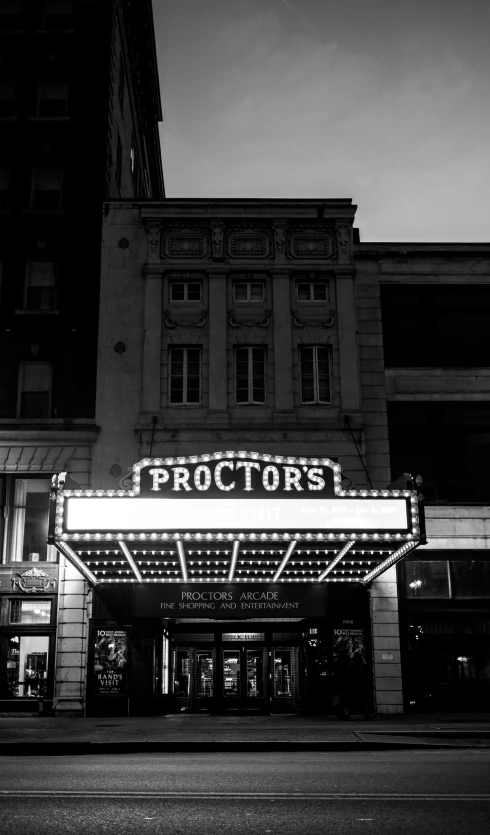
[337,272,361,414]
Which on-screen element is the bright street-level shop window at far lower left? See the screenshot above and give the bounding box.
[7,635,49,699]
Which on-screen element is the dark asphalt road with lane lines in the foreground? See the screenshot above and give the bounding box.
[0,750,490,835]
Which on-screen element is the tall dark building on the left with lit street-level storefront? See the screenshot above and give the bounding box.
[0,0,164,711]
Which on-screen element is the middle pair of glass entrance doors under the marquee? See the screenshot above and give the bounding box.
[223,646,266,708]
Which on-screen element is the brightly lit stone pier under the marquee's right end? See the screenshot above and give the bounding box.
[370,566,403,713]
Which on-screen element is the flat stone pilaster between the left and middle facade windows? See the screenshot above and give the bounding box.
[208,272,228,423]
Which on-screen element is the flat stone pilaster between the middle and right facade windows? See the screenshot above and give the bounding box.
[272,272,294,422]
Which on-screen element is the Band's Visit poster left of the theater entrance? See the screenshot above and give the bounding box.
[94,629,128,696]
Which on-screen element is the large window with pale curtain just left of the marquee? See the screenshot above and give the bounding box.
[4,477,56,560]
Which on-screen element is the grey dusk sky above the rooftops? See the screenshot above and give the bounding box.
[153,0,490,241]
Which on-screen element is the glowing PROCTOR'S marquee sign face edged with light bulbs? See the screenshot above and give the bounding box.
[55,452,418,540]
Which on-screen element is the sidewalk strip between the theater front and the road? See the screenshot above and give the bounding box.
[0,713,490,756]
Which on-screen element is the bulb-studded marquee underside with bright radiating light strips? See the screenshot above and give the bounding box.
[55,539,418,585]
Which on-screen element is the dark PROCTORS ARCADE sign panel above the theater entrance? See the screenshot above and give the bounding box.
[134,583,326,620]
